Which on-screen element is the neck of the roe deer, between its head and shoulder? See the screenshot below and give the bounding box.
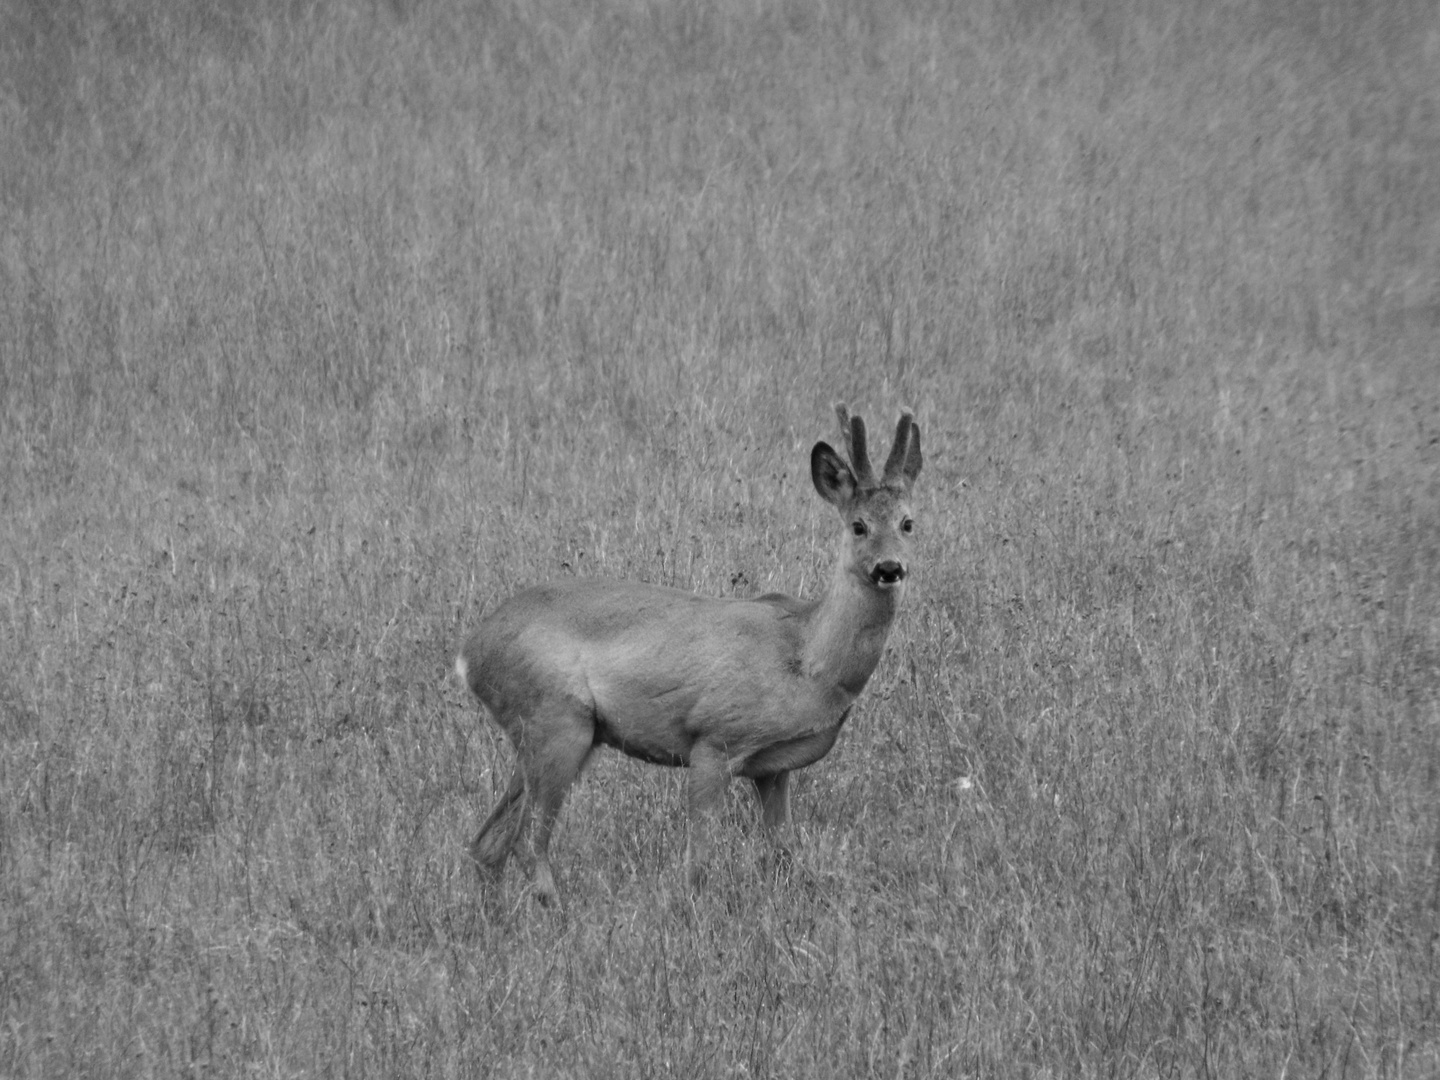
[805,560,903,700]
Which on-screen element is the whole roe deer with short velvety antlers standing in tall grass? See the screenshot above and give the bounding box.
[455,405,920,903]
